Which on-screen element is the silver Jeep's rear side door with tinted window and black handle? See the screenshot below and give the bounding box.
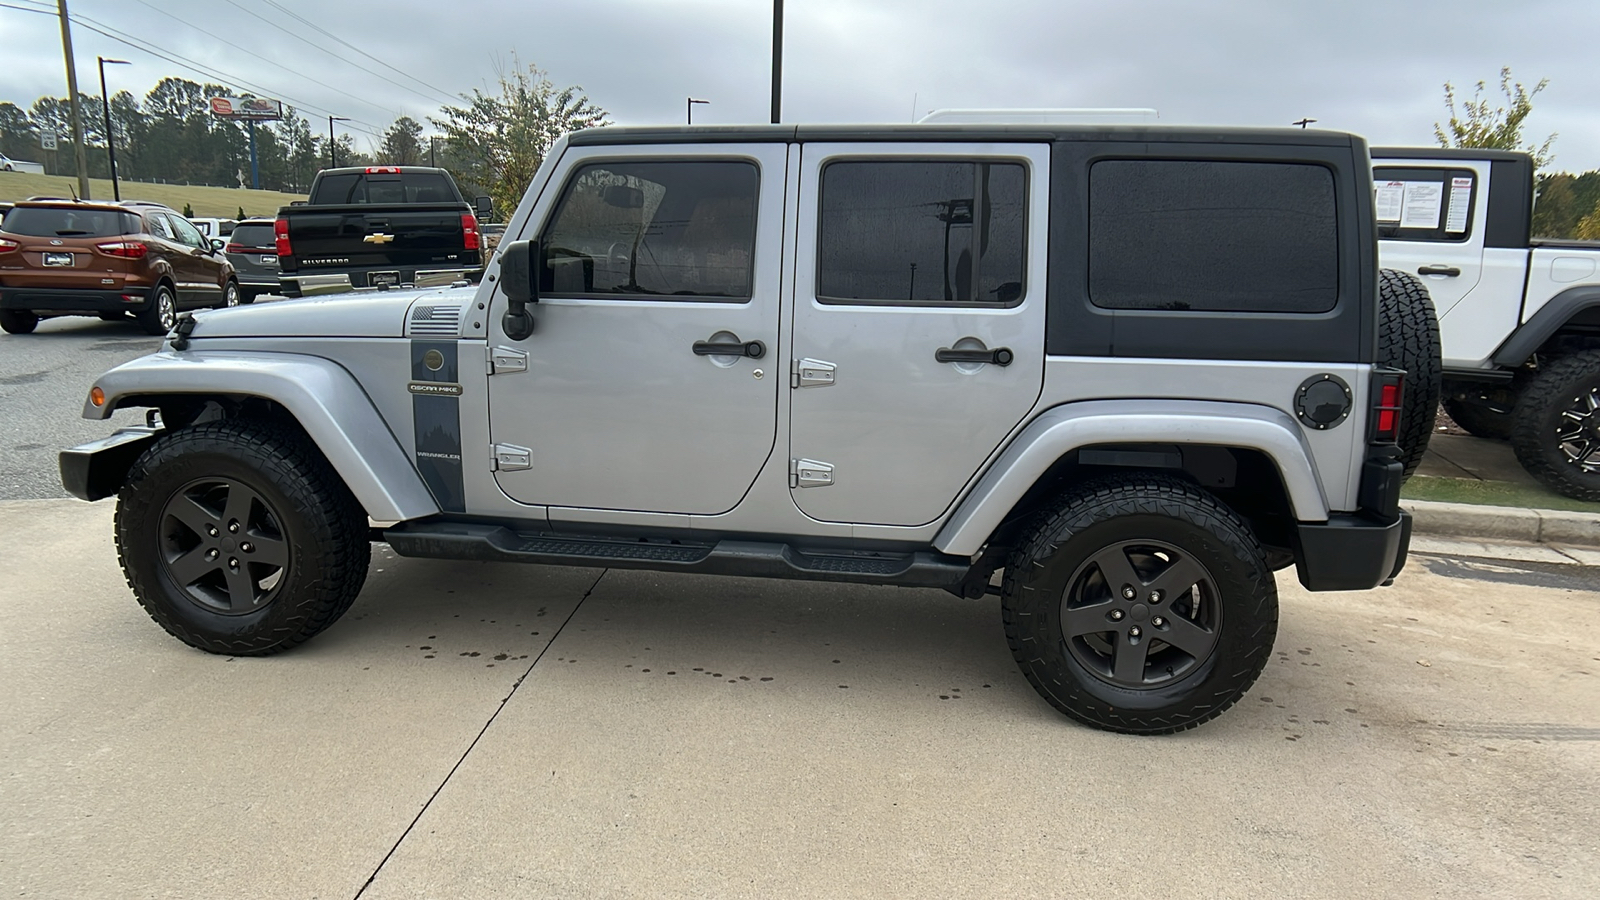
[789,143,1050,525]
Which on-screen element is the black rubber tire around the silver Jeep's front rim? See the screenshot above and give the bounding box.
[115,420,371,657]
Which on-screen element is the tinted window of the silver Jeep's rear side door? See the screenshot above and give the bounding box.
[816,160,1027,306]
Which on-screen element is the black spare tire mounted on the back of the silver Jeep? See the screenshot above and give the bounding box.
[1378,269,1445,477]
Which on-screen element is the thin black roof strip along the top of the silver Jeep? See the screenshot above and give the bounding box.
[568,122,1360,147]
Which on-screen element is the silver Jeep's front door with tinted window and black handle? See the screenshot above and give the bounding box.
[488,144,789,514]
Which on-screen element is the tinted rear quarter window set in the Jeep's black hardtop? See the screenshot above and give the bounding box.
[1088,160,1339,312]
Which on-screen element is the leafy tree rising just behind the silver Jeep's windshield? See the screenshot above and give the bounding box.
[430,58,606,211]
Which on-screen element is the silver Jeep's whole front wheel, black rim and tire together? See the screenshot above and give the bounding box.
[115,421,371,657]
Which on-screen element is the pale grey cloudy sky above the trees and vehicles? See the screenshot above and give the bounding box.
[0,0,1600,171]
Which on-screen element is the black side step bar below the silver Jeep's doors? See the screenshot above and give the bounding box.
[382,522,971,591]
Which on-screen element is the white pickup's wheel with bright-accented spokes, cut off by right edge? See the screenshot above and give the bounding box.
[1510,351,1600,501]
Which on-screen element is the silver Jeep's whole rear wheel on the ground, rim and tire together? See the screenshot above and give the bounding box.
[1002,474,1278,735]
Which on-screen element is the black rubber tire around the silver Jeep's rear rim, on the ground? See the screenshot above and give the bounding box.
[1000,474,1278,735]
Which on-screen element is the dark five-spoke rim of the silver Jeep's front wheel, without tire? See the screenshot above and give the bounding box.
[160,477,290,615]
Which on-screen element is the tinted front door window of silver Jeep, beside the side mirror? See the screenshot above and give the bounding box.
[539,162,760,299]
